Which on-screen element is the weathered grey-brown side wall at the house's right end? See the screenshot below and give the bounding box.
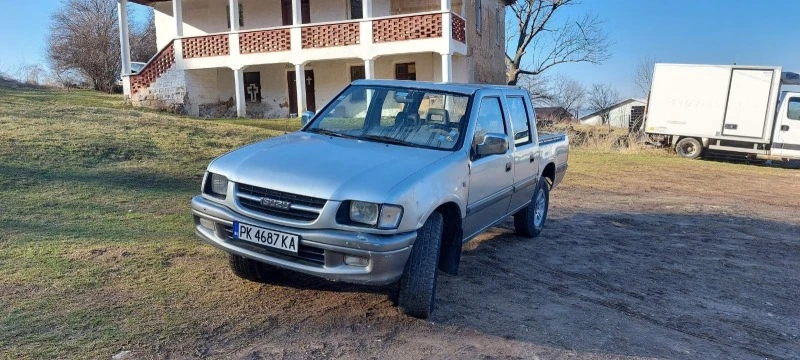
[465,0,506,84]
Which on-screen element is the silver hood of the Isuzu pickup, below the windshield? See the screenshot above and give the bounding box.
[208,132,452,202]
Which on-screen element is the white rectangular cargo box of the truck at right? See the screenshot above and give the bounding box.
[645,64,782,143]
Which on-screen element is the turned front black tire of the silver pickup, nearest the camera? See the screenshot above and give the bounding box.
[397,212,444,319]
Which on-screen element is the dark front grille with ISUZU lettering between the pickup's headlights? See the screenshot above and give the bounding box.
[236,184,327,221]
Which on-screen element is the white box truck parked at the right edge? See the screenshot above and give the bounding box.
[644,64,800,162]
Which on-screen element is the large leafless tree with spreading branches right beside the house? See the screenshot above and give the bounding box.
[506,0,611,85]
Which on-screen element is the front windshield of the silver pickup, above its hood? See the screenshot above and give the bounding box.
[305,85,469,150]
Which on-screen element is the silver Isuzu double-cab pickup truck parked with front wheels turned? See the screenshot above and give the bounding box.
[192,80,569,318]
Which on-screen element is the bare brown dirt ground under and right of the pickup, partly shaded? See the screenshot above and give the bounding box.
[167,160,800,359]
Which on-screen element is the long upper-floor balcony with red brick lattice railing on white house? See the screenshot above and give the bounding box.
[171,11,466,69]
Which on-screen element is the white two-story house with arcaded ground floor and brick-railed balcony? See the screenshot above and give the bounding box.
[117,0,508,118]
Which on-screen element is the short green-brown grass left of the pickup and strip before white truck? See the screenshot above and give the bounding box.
[0,89,792,358]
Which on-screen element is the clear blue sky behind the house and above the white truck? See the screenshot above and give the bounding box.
[0,0,800,97]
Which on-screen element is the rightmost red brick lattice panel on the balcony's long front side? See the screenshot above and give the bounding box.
[372,14,442,43]
